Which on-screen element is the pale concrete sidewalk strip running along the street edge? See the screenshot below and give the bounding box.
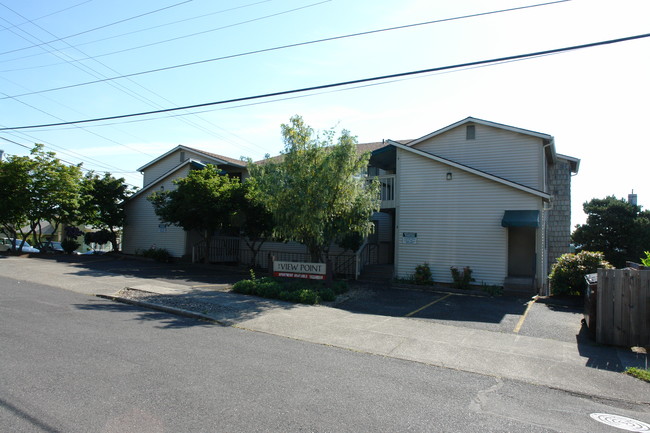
[0,258,650,404]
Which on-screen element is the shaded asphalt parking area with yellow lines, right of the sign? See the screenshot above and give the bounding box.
[337,288,585,343]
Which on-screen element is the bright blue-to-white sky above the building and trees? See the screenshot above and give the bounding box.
[0,0,650,228]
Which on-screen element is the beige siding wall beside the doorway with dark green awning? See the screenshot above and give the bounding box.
[395,149,542,285]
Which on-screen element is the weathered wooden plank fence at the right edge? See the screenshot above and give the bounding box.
[596,269,650,347]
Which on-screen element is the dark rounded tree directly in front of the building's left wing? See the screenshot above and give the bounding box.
[148,165,240,262]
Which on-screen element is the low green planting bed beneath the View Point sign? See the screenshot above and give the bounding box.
[232,270,348,305]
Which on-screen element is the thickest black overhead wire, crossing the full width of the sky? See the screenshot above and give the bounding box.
[0,33,650,131]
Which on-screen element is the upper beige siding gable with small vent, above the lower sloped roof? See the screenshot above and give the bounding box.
[414,124,545,190]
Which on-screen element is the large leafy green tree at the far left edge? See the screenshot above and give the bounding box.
[0,144,81,250]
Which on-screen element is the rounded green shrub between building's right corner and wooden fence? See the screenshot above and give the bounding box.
[548,251,613,295]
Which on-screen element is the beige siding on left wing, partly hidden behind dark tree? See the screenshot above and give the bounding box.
[123,166,189,257]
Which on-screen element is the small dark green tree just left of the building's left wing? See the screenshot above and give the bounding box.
[81,171,133,251]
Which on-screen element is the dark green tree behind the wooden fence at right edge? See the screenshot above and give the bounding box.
[572,196,650,267]
